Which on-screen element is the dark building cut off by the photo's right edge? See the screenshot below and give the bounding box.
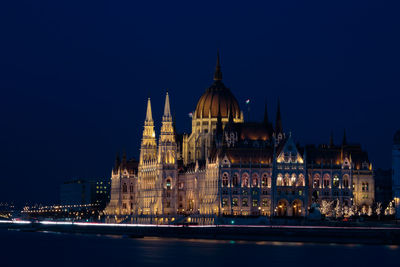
[392,130,400,219]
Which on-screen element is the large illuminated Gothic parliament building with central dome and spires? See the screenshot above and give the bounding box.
[105,54,374,223]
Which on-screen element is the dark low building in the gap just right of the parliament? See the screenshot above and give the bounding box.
[374,169,393,207]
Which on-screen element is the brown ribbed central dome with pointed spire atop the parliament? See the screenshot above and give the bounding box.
[194,56,240,119]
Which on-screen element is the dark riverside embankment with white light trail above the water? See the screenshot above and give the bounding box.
[0,221,400,245]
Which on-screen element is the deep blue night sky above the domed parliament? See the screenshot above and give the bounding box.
[0,0,400,203]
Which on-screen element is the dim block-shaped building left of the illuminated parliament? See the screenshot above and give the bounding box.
[60,179,110,208]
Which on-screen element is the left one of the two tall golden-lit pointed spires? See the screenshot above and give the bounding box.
[140,98,157,164]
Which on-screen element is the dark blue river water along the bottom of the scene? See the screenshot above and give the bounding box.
[0,229,400,267]
